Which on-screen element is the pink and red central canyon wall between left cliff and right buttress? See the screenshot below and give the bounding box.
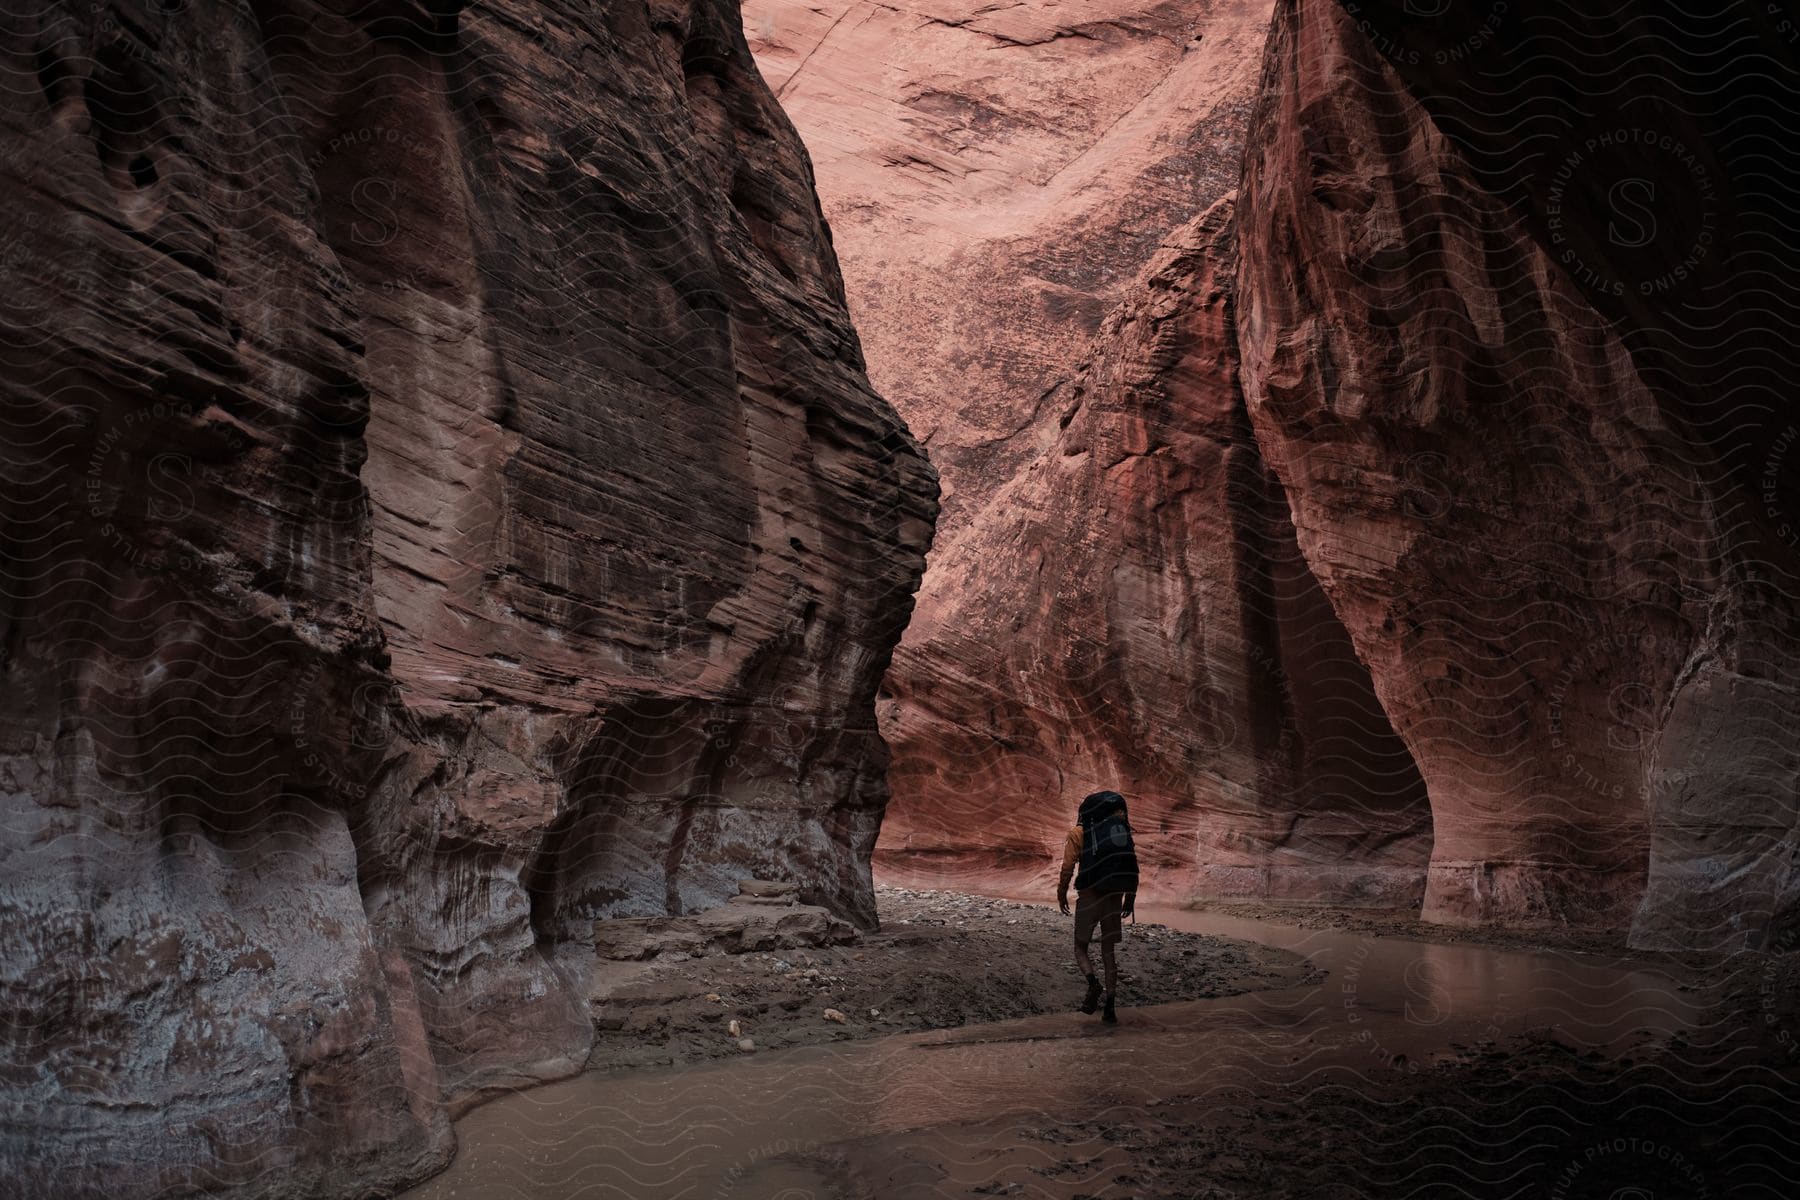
[743,0,1339,896]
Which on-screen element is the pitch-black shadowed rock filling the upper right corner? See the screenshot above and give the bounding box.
[1303,0,1800,543]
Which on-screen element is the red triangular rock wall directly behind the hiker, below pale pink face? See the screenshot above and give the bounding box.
[880,198,1431,905]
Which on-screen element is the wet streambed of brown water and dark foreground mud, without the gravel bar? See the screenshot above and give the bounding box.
[407,905,1800,1200]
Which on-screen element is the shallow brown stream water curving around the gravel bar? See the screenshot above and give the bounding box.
[405,909,1703,1200]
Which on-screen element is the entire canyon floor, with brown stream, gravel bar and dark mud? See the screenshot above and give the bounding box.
[409,889,1800,1200]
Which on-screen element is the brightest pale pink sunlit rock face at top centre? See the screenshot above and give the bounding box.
[743,0,1269,536]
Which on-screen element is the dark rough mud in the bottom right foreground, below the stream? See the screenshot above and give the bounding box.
[943,1036,1800,1200]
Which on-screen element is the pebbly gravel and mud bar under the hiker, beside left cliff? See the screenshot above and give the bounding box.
[589,887,1319,1070]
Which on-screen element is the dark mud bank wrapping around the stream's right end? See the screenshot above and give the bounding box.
[839,905,1800,1200]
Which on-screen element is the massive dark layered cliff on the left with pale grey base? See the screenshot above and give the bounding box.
[0,0,934,1196]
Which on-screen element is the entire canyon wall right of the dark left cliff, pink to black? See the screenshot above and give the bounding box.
[763,0,1800,946]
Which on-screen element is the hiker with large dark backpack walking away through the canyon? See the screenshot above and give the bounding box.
[1057,792,1138,1025]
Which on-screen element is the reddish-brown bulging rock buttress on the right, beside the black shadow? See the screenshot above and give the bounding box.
[1238,0,1800,945]
